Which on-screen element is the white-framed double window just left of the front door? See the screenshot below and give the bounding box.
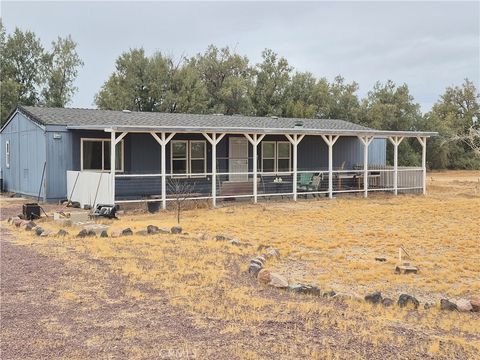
[170,140,207,177]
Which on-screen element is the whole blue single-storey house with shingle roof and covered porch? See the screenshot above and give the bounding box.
[0,106,435,208]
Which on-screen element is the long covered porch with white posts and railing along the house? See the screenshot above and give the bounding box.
[67,127,427,209]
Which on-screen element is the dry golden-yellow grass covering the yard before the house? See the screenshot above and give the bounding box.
[1,171,480,359]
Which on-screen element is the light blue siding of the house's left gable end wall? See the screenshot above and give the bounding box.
[1,113,46,199]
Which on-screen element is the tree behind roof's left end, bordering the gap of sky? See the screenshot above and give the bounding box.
[42,35,83,107]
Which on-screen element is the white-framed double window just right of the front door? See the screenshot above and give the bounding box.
[262,141,292,174]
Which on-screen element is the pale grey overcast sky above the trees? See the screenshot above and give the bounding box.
[1,1,480,111]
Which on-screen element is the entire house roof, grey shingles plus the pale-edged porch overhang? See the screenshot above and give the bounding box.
[18,106,437,137]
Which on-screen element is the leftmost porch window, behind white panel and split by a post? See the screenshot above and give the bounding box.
[80,138,124,172]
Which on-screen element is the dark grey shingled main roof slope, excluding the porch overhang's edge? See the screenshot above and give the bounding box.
[19,106,369,130]
